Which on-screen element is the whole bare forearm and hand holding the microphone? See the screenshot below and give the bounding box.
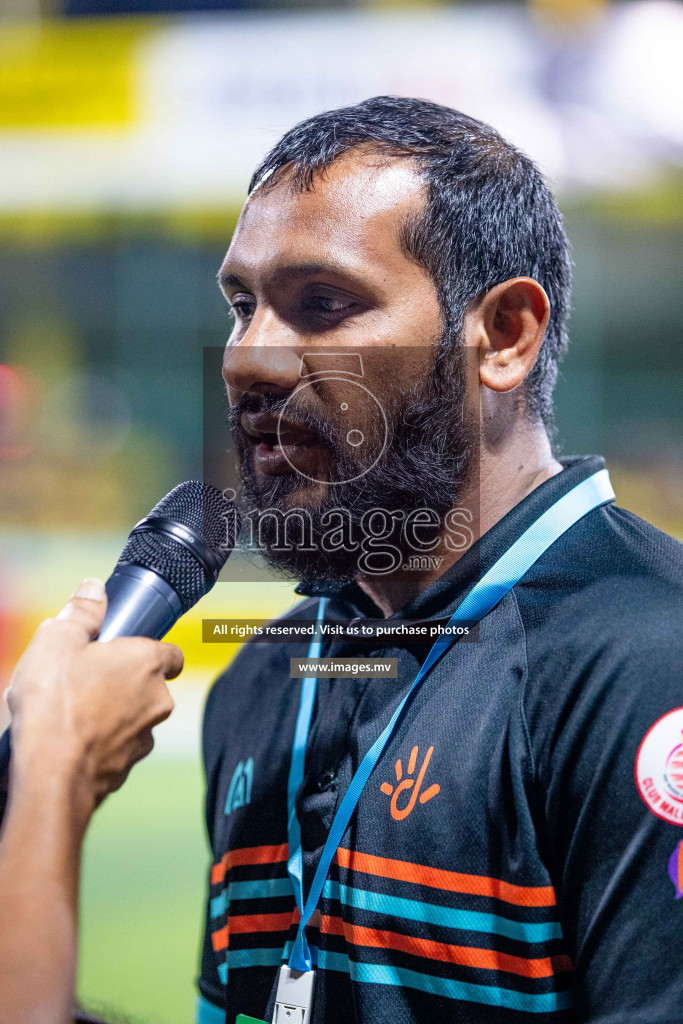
[0,581,182,1024]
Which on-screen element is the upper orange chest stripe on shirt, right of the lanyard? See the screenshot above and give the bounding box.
[337,847,556,906]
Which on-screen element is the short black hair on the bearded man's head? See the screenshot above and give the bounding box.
[250,96,571,427]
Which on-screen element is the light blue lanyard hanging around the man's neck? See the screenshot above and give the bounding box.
[287,469,614,971]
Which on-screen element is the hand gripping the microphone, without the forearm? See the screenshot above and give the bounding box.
[7,580,183,814]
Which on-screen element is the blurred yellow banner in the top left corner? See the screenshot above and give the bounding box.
[0,18,150,131]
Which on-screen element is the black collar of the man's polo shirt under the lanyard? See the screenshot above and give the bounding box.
[296,455,605,618]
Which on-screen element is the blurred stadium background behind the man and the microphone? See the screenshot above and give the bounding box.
[0,0,683,1024]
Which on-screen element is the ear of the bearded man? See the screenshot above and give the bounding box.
[469,278,550,391]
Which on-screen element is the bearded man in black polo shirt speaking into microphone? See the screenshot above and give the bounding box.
[199,97,683,1024]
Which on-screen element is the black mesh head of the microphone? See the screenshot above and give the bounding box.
[119,480,240,612]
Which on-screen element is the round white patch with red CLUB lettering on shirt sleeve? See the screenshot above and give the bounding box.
[636,708,683,825]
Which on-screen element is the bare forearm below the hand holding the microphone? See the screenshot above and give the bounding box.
[0,751,93,1024]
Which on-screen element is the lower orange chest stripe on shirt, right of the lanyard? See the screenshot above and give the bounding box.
[321,914,571,978]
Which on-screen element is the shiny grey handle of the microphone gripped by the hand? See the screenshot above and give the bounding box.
[0,565,183,782]
